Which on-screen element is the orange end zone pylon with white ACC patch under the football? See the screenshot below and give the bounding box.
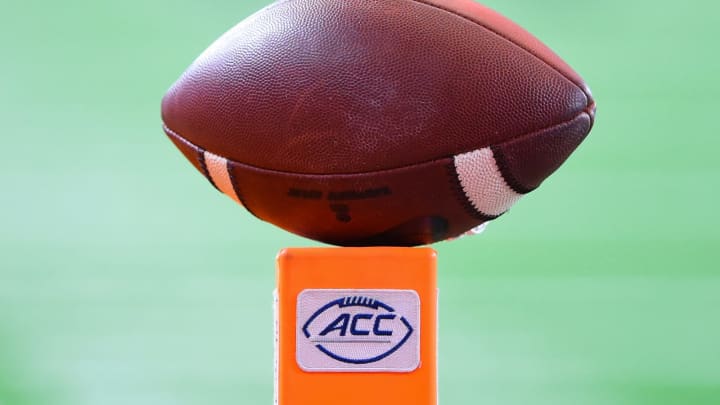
[275,248,437,405]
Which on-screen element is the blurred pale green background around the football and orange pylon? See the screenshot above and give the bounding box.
[0,0,720,405]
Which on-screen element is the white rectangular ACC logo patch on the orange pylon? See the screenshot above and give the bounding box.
[298,290,420,371]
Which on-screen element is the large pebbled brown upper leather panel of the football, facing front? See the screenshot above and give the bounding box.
[163,0,588,174]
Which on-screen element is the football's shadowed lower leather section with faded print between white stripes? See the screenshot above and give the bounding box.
[228,154,491,246]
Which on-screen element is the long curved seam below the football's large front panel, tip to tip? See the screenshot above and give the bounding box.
[163,111,588,177]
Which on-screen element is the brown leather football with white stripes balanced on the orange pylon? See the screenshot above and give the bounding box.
[162,0,595,246]
